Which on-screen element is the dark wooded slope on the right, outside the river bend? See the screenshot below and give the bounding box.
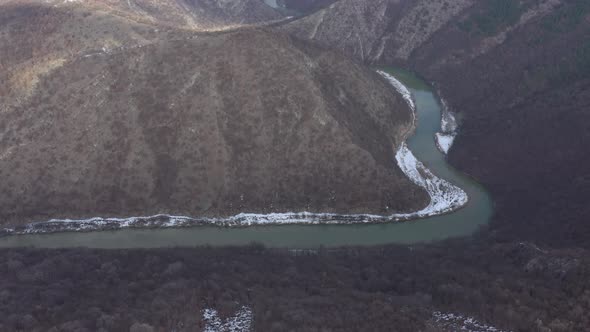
[413,0,590,246]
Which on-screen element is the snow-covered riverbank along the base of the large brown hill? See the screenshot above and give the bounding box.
[0,70,468,236]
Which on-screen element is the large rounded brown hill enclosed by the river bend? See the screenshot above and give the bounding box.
[0,29,428,223]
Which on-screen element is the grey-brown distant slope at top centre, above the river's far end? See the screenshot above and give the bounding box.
[282,0,474,63]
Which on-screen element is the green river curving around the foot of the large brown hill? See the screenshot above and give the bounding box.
[0,69,493,248]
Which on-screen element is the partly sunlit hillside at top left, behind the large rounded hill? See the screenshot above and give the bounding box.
[0,0,282,73]
